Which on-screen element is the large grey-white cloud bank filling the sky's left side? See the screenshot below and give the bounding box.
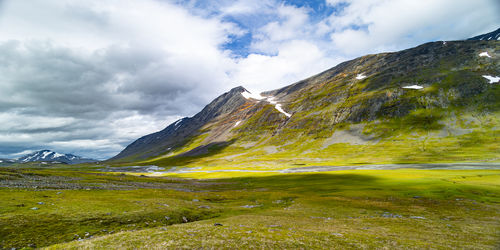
[0,0,240,158]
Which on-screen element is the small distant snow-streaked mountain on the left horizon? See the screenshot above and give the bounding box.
[17,149,97,164]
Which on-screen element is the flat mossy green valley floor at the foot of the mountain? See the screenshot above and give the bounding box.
[0,166,500,249]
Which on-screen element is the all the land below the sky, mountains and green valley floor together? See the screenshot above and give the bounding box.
[0,30,500,249]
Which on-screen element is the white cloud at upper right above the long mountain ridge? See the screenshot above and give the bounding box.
[322,0,500,55]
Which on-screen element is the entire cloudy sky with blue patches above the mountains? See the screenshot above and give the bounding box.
[0,0,500,159]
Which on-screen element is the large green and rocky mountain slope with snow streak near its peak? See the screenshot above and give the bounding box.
[108,37,500,166]
